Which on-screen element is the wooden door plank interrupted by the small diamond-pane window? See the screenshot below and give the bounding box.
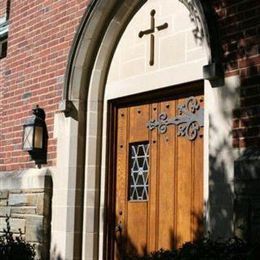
[125,105,149,254]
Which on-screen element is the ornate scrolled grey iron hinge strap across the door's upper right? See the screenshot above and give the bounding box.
[147,97,204,141]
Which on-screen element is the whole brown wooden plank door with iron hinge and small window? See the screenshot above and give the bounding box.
[107,84,204,259]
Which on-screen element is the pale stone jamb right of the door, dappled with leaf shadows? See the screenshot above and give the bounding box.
[207,68,238,239]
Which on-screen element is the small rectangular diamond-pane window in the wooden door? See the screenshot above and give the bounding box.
[129,143,149,201]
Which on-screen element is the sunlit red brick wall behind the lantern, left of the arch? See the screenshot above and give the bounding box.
[0,0,89,171]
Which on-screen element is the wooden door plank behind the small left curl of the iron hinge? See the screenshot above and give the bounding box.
[157,101,176,248]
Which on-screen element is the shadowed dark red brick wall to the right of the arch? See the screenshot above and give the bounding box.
[215,0,260,148]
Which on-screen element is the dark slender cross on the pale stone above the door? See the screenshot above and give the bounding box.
[138,9,168,66]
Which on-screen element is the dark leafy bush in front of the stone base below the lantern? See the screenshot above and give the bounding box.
[0,217,35,260]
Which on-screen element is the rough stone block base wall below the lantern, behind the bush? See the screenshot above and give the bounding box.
[0,168,52,259]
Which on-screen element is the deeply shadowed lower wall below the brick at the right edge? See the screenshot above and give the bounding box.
[234,147,260,242]
